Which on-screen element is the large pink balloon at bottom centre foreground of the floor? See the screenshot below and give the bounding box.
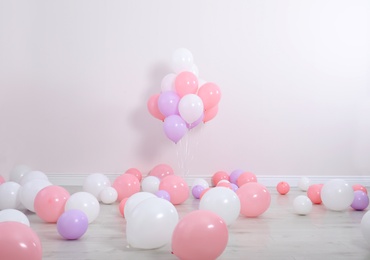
[172,210,229,260]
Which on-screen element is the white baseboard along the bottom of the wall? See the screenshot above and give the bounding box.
[47,173,370,187]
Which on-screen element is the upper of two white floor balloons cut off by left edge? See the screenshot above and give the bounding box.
[0,181,21,210]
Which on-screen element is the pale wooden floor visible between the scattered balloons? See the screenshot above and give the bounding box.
[28,187,370,260]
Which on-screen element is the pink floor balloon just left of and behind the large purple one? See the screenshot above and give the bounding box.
[34,185,70,223]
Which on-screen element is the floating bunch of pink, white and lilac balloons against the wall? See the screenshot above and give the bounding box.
[147,48,221,143]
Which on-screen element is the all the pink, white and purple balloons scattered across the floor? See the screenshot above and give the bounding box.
[0,164,370,260]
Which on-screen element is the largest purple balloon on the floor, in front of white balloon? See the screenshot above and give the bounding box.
[57,209,89,240]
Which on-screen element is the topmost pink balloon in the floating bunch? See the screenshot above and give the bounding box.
[175,71,198,98]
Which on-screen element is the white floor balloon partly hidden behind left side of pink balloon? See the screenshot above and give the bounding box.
[19,179,52,212]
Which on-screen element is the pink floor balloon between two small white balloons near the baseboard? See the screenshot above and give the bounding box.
[112,174,140,202]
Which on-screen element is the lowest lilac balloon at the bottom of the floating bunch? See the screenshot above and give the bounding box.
[163,115,188,143]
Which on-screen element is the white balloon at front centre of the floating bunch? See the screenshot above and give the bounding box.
[178,94,204,124]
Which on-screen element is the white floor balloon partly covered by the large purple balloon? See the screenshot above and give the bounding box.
[64,191,100,223]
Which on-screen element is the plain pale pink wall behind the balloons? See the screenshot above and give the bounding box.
[0,0,370,180]
